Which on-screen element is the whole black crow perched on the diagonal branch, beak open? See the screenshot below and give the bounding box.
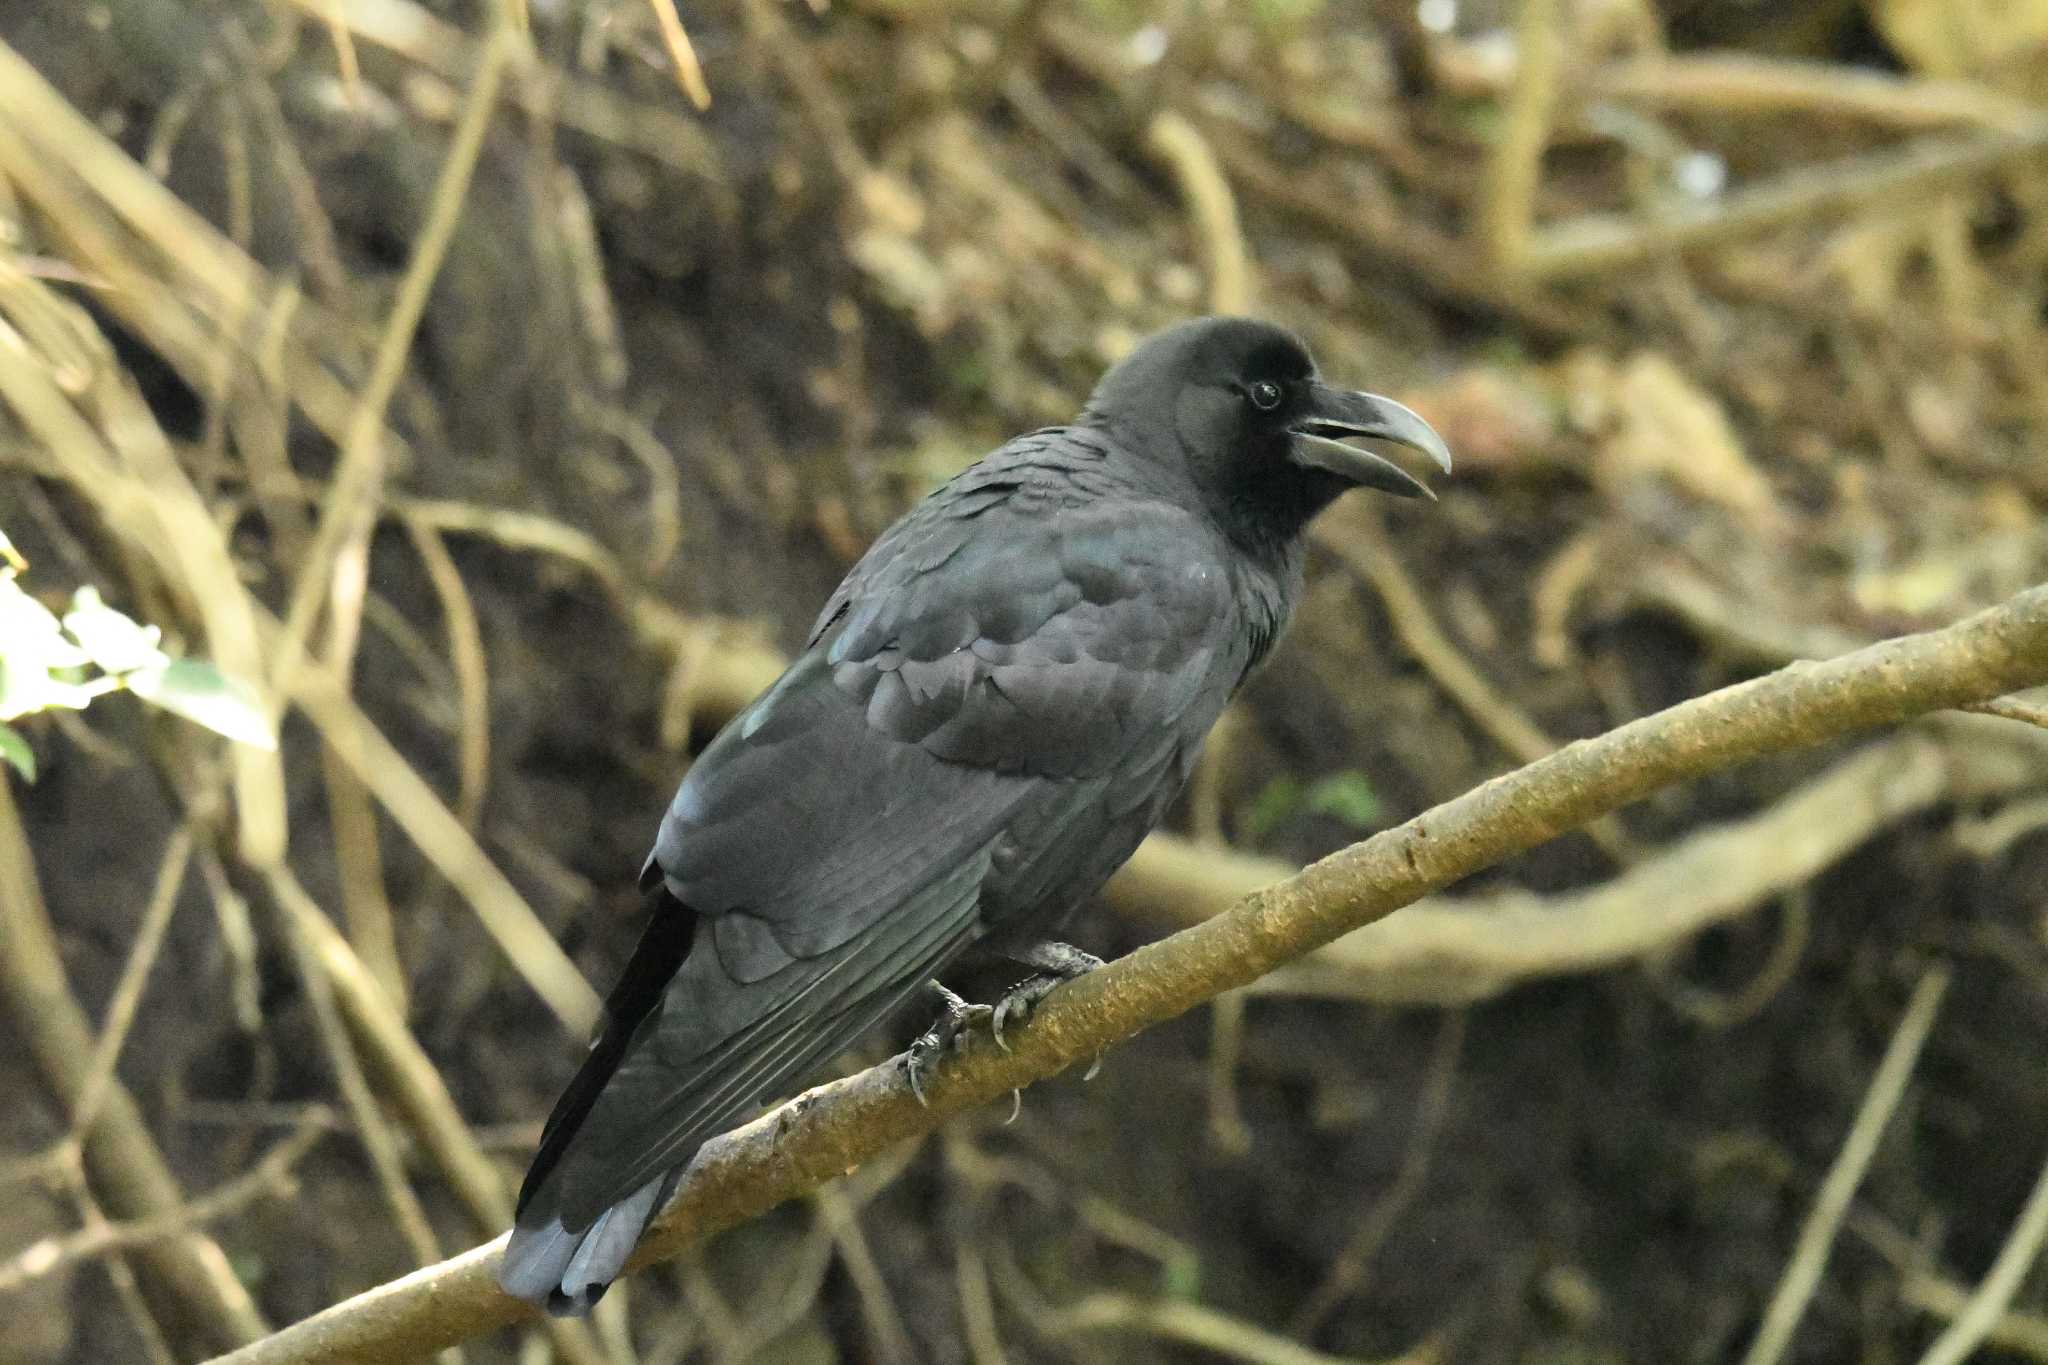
[498,317,1450,1314]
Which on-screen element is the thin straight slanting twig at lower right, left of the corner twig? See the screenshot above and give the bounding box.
[1743,966,1950,1365]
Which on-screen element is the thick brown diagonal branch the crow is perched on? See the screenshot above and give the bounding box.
[207,587,2048,1365]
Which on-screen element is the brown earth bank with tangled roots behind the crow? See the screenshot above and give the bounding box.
[0,0,2048,1365]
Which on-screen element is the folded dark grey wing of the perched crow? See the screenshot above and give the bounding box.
[522,448,1249,1228]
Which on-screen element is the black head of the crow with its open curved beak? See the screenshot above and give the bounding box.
[1081,317,1450,534]
